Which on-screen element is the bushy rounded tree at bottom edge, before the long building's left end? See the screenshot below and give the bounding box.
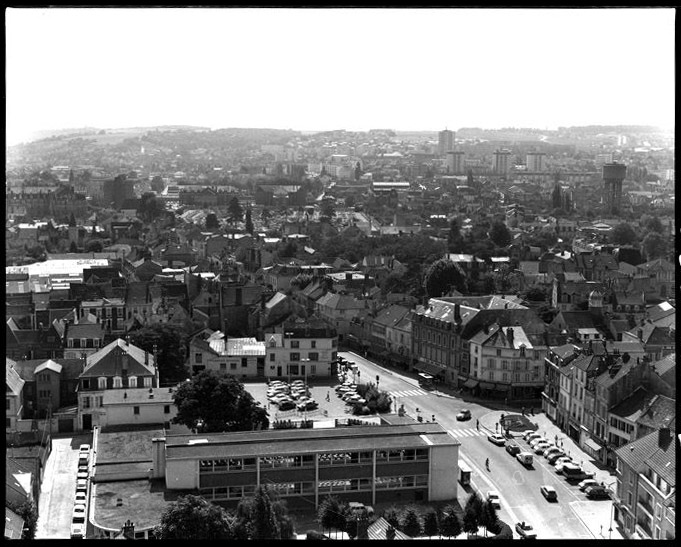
[154,494,235,540]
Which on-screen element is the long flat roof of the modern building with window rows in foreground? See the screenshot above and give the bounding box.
[166,423,461,461]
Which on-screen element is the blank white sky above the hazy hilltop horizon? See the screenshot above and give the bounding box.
[5,7,675,145]
